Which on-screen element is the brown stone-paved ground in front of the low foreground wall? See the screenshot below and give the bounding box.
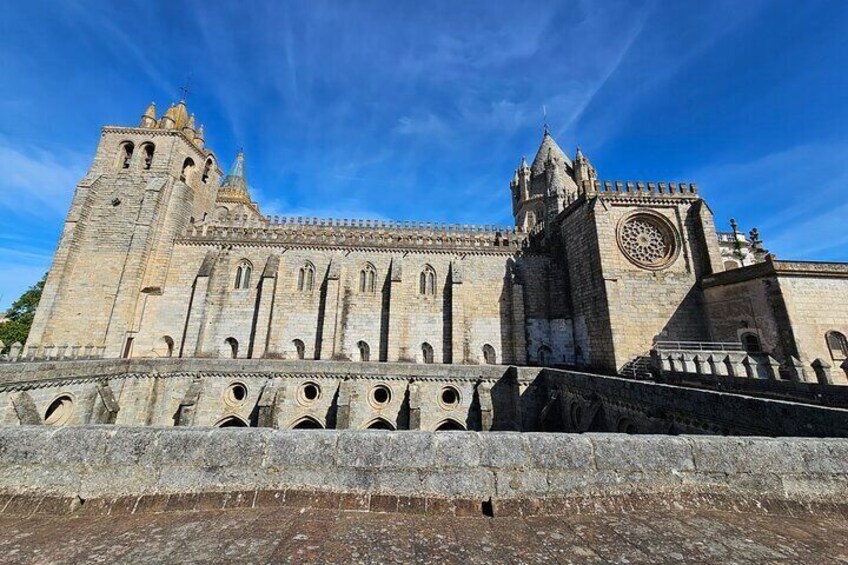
[0,508,848,565]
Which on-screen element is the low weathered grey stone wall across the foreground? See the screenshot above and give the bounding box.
[0,426,848,507]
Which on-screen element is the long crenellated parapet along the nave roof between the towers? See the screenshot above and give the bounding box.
[178,215,527,251]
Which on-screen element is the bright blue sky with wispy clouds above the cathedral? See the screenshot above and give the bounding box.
[0,0,848,308]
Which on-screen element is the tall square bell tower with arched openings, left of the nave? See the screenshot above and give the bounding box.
[27,101,221,358]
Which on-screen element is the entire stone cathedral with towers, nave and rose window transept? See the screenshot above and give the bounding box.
[13,101,848,382]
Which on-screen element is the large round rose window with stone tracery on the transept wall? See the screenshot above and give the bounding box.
[618,213,678,270]
